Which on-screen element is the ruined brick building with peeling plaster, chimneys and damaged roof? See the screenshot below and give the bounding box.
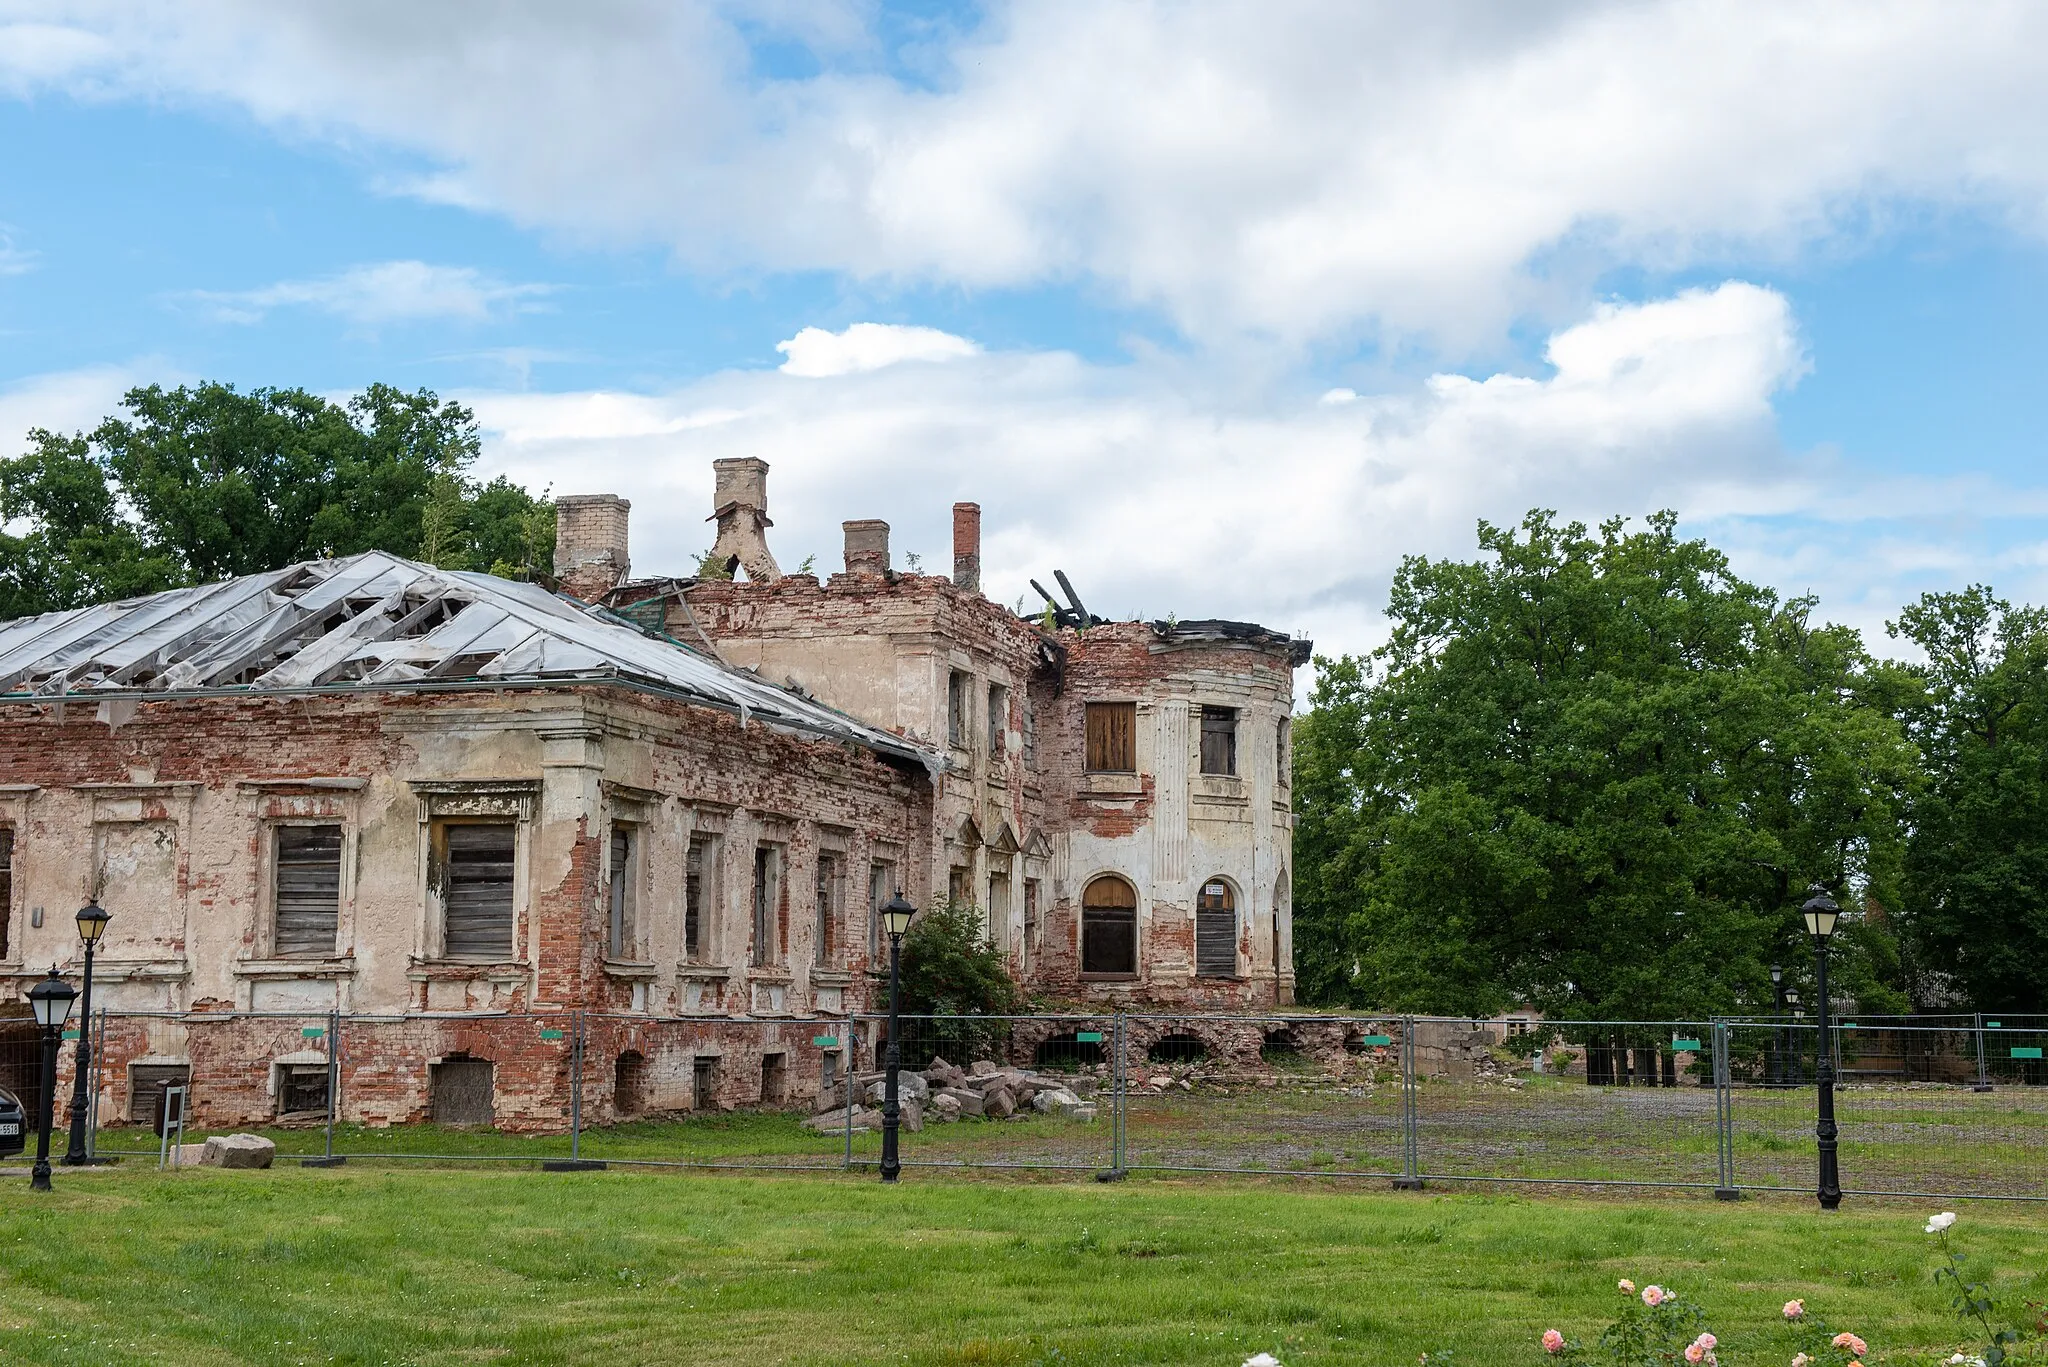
[0,459,1307,1125]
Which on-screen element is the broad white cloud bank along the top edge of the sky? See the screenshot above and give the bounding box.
[12,0,2048,346]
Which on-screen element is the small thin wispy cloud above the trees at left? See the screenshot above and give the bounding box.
[184,260,551,328]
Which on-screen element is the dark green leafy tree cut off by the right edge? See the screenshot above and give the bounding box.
[1888,584,2048,1010]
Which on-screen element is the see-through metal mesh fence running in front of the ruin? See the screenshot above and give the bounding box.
[48,1012,2048,1199]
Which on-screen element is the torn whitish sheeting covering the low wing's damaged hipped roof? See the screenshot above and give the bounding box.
[0,551,944,773]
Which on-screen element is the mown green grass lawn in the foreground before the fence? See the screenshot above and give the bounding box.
[0,1166,2048,1367]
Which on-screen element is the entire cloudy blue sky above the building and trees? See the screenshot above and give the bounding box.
[0,0,2048,664]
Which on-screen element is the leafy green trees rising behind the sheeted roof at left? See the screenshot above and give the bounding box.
[0,383,553,617]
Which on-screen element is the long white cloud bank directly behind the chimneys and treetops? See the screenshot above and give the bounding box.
[448,283,2048,664]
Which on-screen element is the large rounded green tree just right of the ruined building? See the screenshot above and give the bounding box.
[1294,512,1913,1019]
